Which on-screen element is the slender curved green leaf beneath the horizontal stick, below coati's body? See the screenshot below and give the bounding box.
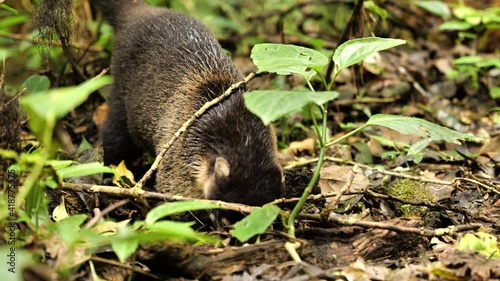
[146,201,220,224]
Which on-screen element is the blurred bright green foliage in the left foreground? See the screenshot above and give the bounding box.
[0,75,223,280]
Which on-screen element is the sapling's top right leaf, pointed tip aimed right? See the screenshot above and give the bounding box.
[332,37,406,72]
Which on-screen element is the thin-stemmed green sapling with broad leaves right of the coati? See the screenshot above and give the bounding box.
[244,37,476,243]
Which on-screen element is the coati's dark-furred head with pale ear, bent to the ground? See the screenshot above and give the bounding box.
[186,93,284,206]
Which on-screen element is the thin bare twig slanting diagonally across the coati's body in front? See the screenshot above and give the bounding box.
[134,73,255,188]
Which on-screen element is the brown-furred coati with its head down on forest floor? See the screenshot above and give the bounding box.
[96,0,284,205]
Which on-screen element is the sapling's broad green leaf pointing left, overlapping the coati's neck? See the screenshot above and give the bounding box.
[243,91,339,125]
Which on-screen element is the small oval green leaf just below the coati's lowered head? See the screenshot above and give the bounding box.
[231,204,281,242]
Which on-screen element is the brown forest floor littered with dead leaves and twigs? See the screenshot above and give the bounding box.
[0,0,500,280]
